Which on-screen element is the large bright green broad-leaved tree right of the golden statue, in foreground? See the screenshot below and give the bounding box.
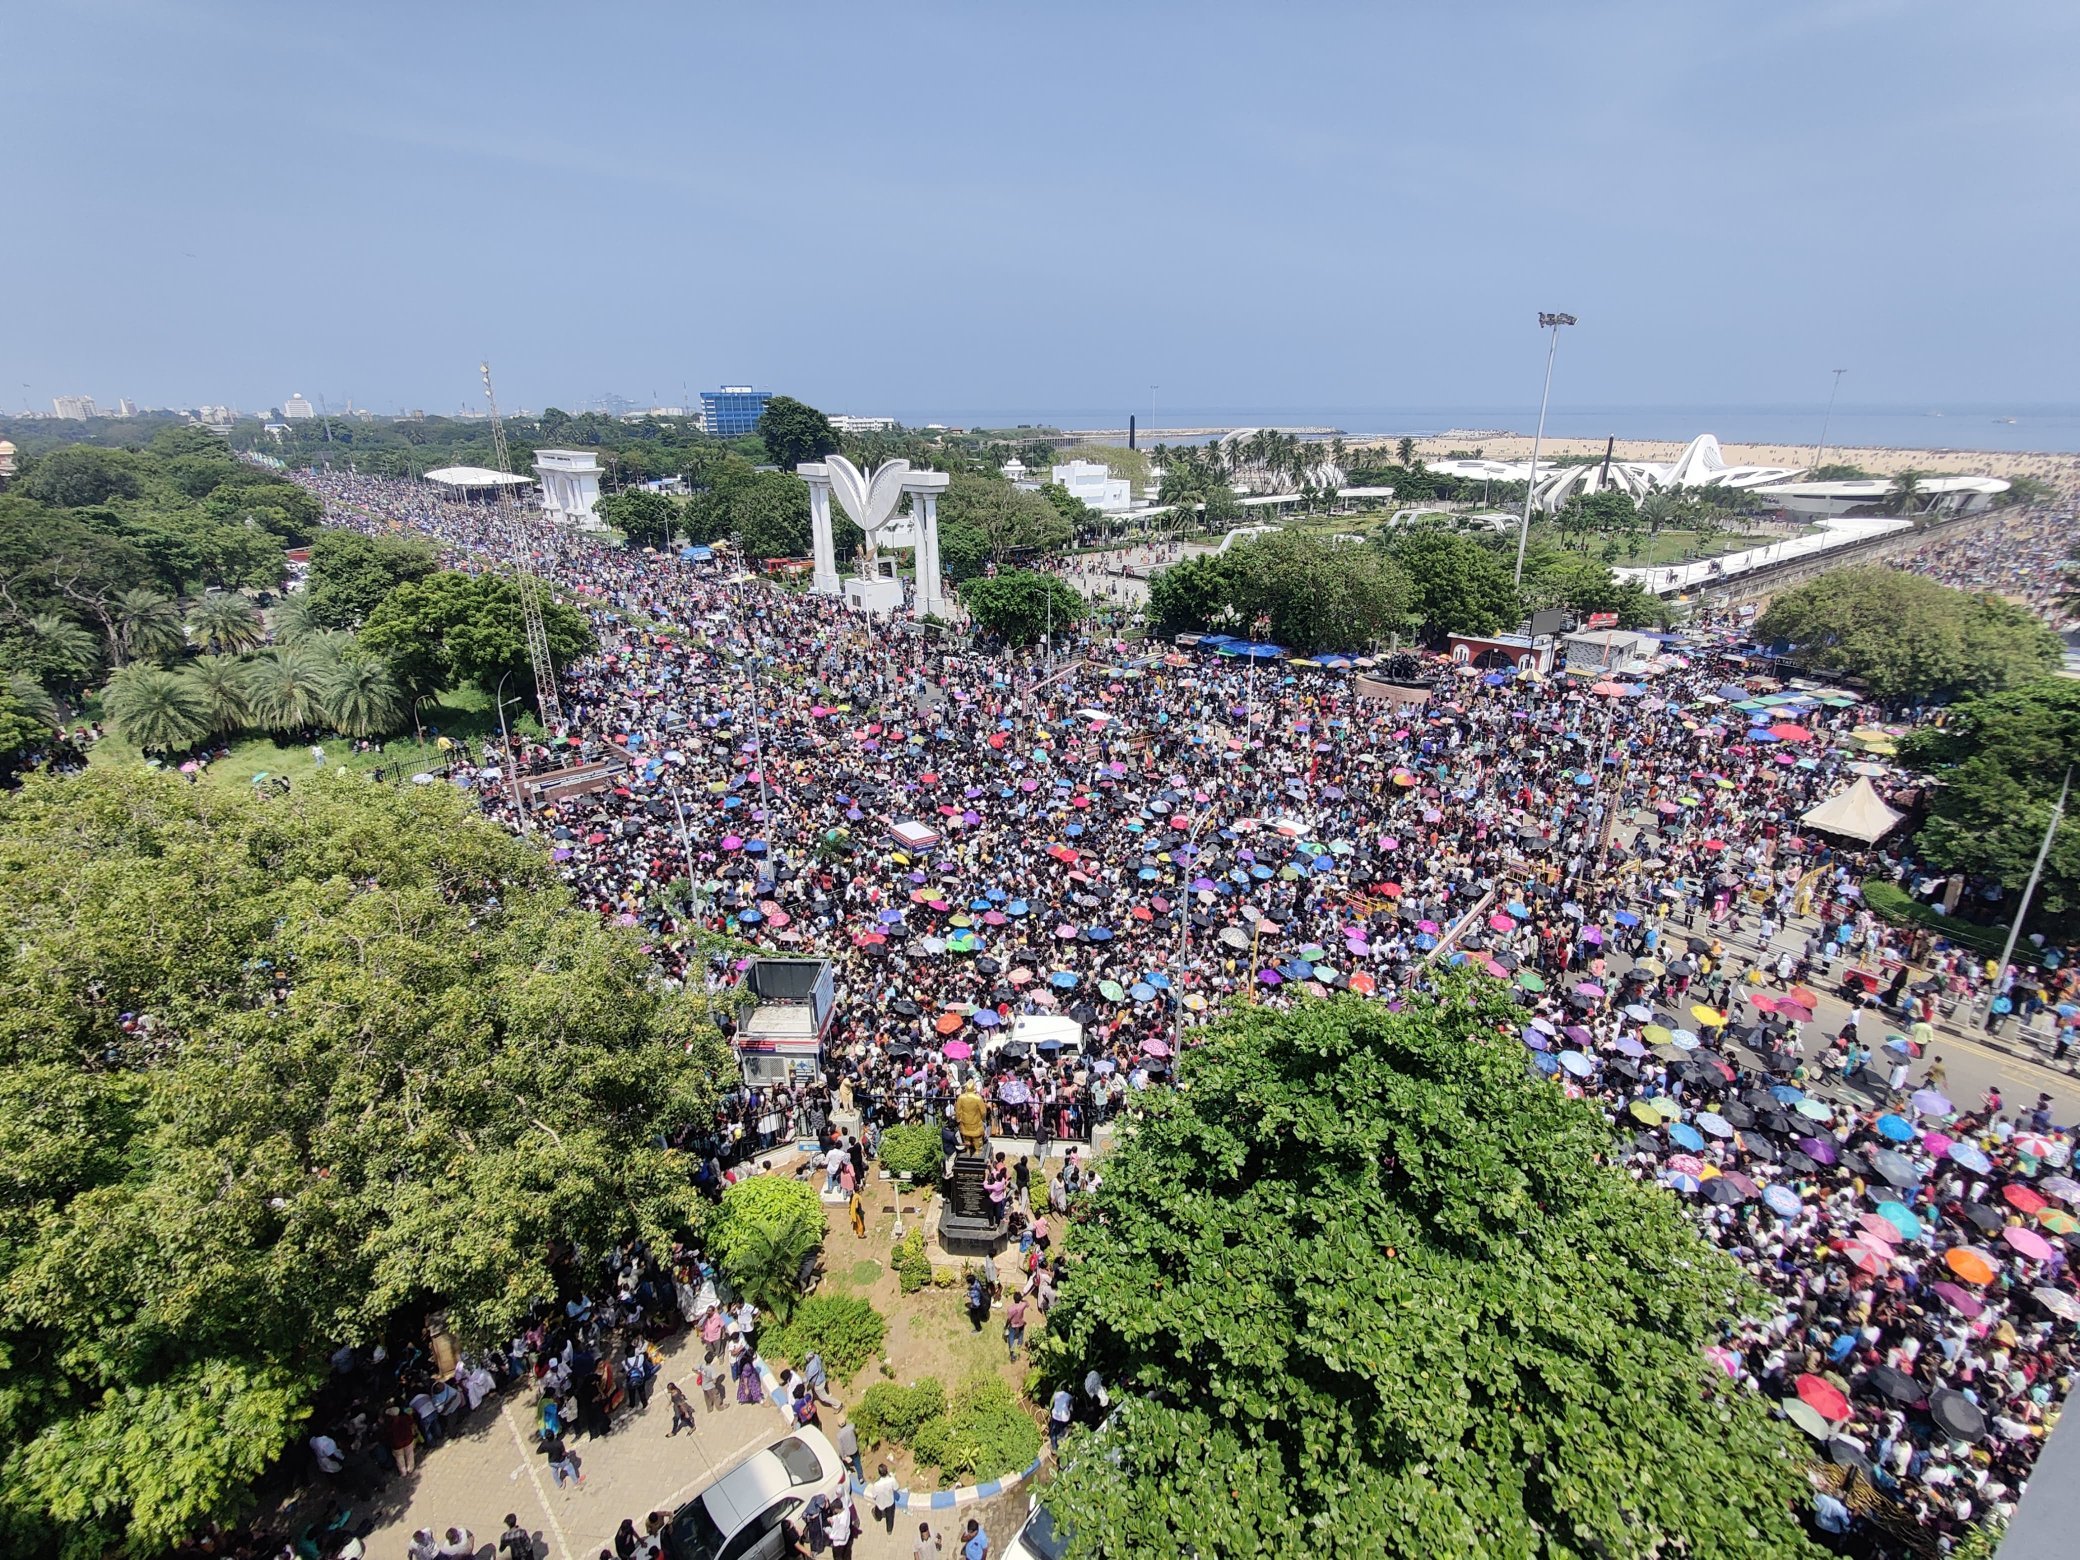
[1042,990,1816,1560]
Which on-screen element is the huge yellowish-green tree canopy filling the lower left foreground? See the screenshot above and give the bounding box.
[0,777,728,1558]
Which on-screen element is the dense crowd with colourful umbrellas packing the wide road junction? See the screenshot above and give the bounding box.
[310,476,2080,1555]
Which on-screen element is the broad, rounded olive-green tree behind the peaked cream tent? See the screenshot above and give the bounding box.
[1756,564,2061,699]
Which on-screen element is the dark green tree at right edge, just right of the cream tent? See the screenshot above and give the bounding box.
[1899,678,2080,921]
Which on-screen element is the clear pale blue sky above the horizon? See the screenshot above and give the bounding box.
[0,0,2080,414]
